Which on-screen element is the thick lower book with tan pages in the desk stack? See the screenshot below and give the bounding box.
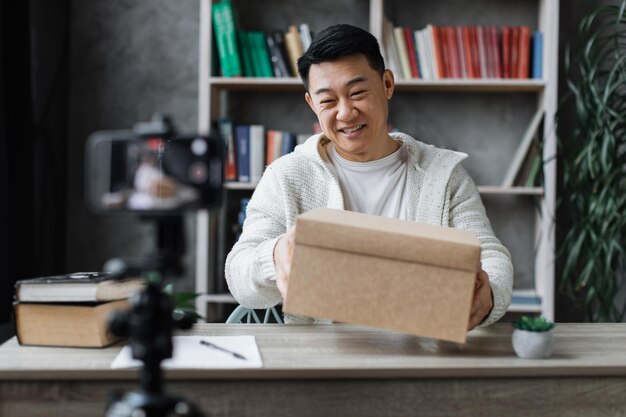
[13,300,128,347]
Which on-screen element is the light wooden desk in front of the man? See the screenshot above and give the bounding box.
[0,324,626,417]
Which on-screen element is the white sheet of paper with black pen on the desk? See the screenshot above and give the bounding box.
[111,336,263,369]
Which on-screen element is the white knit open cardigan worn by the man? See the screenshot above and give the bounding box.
[226,133,513,325]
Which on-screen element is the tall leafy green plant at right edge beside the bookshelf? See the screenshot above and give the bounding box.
[557,0,626,321]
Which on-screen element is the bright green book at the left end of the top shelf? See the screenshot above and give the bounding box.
[211,0,243,77]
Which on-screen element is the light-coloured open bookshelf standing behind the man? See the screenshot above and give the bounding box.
[196,0,559,319]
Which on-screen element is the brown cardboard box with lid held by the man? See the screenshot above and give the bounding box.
[283,208,480,343]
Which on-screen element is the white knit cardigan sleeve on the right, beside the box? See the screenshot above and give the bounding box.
[448,164,513,326]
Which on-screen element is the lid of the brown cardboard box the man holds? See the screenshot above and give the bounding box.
[295,208,480,271]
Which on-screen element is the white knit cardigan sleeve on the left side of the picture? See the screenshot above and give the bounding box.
[225,166,290,308]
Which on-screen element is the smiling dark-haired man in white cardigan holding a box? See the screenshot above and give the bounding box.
[226,25,513,329]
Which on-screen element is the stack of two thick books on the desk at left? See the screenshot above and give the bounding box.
[13,272,145,347]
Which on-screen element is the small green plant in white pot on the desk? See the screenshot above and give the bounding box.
[511,316,554,359]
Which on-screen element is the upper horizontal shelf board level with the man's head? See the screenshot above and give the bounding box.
[209,77,546,93]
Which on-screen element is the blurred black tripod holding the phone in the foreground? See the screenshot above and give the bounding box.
[107,217,202,417]
